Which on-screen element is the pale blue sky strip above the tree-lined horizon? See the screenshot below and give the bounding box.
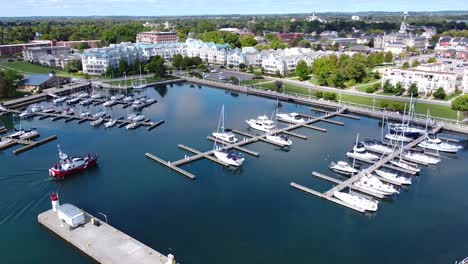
[0,0,468,16]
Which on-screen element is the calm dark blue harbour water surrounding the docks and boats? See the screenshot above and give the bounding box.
[0,84,468,264]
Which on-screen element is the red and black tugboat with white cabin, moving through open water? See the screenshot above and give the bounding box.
[49,146,98,179]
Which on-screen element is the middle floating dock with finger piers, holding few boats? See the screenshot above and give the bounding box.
[145,108,354,179]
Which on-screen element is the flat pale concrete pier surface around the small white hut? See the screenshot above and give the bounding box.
[37,209,172,264]
